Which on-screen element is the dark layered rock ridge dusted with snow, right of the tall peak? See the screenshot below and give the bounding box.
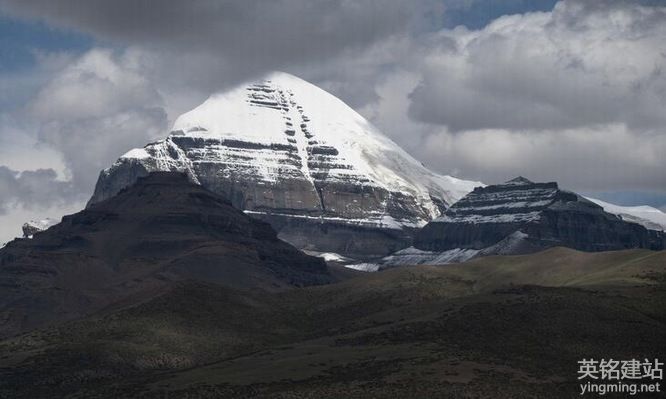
[415,177,664,254]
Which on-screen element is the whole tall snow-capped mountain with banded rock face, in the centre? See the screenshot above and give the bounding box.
[91,72,482,255]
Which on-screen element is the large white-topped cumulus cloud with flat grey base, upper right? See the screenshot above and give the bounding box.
[410,1,666,131]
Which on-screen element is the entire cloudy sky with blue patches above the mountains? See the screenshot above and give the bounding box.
[0,0,666,242]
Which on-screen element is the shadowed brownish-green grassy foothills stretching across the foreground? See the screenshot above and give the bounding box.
[0,248,666,398]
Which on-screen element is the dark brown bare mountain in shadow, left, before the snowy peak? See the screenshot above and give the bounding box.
[0,172,330,336]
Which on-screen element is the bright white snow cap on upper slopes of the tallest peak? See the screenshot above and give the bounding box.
[166,72,481,209]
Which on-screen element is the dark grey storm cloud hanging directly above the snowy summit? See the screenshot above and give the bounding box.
[0,0,417,89]
